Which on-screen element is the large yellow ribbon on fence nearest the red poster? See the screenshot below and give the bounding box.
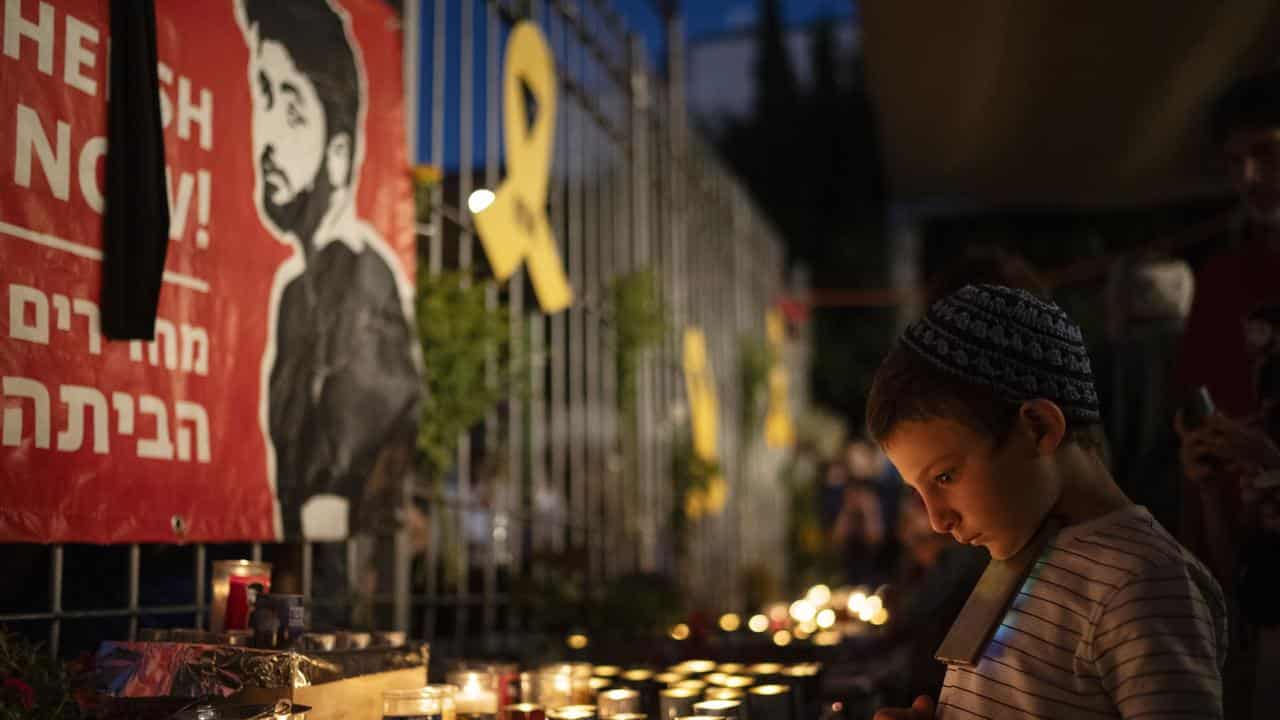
[475,22,573,313]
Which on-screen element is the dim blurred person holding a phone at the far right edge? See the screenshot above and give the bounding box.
[1174,70,1280,717]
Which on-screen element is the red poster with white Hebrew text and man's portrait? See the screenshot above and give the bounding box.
[0,0,417,542]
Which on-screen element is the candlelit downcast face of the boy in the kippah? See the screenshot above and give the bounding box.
[884,419,1061,560]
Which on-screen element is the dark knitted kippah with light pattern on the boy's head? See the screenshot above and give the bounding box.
[902,284,1102,421]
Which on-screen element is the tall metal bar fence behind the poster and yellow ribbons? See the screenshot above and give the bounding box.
[0,0,804,653]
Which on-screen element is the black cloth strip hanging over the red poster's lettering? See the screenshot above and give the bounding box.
[101,0,169,340]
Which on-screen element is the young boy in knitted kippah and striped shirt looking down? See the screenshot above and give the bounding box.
[868,284,1226,720]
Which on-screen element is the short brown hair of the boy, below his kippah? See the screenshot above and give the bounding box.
[867,343,1105,454]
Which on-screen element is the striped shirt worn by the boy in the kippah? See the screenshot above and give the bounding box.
[937,506,1226,720]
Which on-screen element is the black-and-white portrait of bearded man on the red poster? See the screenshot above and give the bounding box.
[237,0,420,539]
